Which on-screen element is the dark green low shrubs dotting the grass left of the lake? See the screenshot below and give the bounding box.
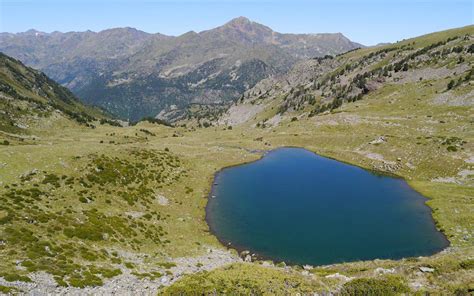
[0,150,184,287]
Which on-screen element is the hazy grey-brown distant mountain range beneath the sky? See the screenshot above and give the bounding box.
[0,17,361,121]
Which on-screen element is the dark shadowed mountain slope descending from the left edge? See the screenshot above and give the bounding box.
[0,53,106,134]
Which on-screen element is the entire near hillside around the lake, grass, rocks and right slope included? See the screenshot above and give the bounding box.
[0,26,474,295]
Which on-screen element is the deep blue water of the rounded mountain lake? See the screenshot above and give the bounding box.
[207,148,448,265]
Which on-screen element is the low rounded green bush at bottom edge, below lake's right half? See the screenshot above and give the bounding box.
[341,277,410,296]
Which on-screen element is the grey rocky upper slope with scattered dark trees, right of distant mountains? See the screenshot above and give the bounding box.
[220,26,474,126]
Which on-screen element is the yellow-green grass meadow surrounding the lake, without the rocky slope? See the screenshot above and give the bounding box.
[0,24,474,294]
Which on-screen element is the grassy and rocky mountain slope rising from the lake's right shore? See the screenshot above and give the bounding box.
[217,26,474,250]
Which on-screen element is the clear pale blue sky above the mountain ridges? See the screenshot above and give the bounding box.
[0,0,474,45]
